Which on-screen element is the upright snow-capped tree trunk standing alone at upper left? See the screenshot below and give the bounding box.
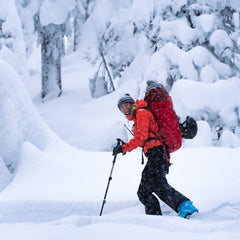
[34,0,75,100]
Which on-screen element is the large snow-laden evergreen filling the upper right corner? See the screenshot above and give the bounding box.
[85,0,240,145]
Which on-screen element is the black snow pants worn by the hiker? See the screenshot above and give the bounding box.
[137,146,189,215]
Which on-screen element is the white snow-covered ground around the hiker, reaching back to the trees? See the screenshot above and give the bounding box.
[0,49,240,240]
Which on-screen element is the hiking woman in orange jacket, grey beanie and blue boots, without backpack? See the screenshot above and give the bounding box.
[113,82,198,218]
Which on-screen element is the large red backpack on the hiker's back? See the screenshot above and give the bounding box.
[144,87,182,153]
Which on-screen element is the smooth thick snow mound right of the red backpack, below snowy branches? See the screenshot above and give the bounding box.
[170,78,240,146]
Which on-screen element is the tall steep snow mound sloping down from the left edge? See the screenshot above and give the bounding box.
[0,60,68,189]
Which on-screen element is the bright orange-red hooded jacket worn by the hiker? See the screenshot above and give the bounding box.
[122,100,163,154]
